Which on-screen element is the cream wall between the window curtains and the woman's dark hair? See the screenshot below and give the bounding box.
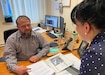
[46,0,82,31]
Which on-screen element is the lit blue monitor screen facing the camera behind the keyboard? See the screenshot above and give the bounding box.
[45,15,58,28]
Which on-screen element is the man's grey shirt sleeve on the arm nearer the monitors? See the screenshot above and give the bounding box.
[37,33,50,59]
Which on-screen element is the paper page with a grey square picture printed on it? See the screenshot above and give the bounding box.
[45,53,72,73]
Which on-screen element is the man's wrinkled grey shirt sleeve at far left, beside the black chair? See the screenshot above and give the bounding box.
[4,38,17,71]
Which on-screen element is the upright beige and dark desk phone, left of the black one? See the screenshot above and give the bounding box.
[62,37,74,50]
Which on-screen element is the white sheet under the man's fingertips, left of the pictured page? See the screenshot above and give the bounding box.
[27,61,54,75]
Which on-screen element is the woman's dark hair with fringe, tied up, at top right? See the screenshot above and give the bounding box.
[71,0,105,30]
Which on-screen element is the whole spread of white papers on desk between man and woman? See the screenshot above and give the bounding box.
[27,53,80,75]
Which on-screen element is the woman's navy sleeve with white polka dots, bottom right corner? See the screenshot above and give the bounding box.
[79,51,105,75]
